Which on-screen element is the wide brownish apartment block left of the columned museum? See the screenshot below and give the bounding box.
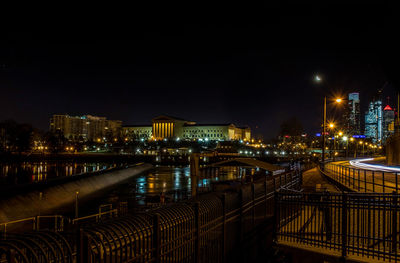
[50,114,122,142]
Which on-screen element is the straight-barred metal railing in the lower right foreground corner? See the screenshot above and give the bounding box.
[275,193,400,262]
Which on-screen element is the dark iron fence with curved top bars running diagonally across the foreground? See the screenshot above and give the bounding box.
[0,171,301,262]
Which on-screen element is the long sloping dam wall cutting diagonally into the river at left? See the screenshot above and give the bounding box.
[0,164,153,223]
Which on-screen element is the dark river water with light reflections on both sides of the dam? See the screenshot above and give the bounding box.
[0,162,254,217]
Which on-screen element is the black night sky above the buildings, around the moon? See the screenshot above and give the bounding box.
[0,5,398,138]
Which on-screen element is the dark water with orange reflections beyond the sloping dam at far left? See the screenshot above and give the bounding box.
[0,162,116,186]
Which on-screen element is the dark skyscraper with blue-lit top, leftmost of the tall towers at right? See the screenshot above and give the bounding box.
[345,92,361,135]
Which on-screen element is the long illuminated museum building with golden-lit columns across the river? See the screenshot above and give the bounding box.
[123,115,251,141]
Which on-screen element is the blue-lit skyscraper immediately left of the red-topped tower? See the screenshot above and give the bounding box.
[364,100,383,143]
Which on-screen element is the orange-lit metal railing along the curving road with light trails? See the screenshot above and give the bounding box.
[324,163,400,193]
